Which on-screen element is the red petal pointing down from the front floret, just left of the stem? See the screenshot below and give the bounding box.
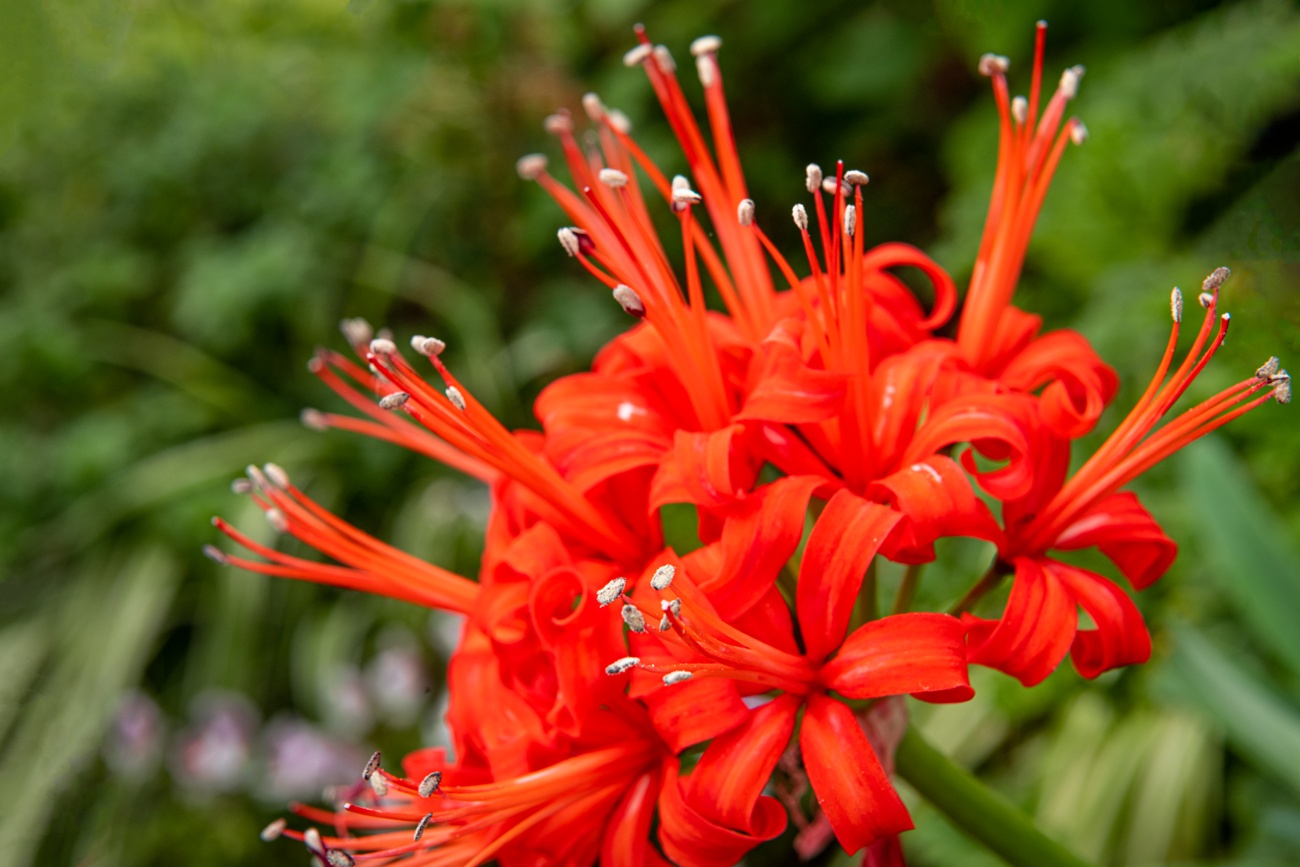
[800,695,913,854]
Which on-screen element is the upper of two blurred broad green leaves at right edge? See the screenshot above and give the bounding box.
[1178,438,1300,675]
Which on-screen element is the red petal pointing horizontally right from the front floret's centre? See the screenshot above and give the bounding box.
[820,612,975,701]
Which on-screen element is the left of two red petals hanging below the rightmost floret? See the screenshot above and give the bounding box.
[962,556,1079,686]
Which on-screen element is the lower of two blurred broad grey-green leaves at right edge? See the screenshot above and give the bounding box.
[1169,627,1300,797]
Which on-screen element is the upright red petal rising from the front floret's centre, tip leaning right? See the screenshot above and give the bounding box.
[796,490,901,660]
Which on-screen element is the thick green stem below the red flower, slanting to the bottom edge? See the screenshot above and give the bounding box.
[894,728,1088,867]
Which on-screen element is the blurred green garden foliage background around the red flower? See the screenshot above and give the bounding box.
[0,0,1300,867]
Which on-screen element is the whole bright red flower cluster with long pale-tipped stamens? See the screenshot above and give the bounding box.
[212,26,1290,867]
